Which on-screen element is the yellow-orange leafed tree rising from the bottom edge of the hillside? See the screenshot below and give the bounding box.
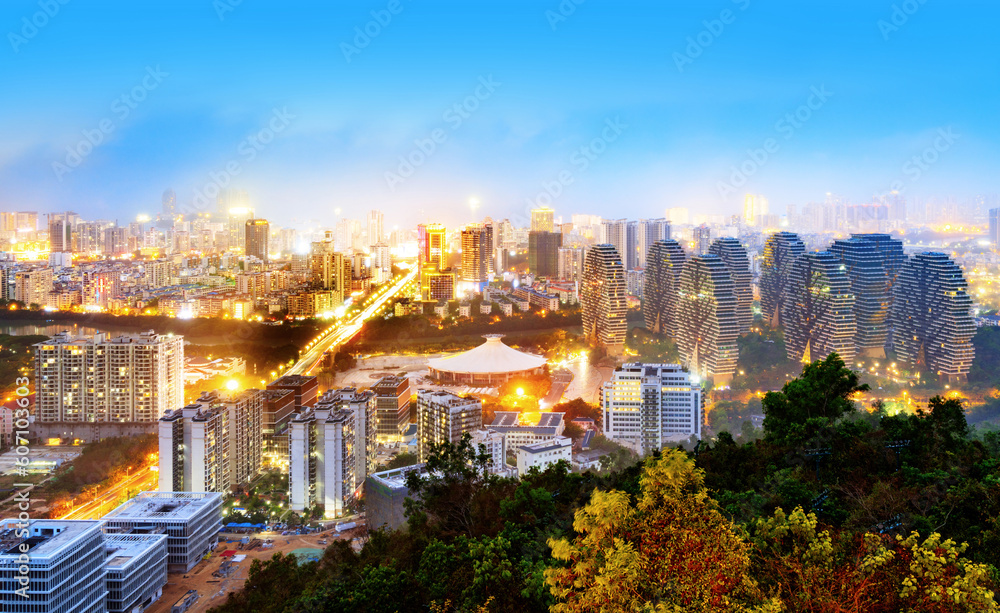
[545,450,780,613]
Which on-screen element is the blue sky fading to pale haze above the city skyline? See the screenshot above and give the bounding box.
[0,0,1000,225]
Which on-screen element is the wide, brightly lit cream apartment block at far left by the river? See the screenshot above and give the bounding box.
[34,331,184,428]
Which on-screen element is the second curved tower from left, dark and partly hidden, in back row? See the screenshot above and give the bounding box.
[642,240,687,336]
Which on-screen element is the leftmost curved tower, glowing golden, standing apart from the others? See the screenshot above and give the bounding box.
[580,244,628,353]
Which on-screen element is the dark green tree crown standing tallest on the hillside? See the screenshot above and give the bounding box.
[763,353,869,443]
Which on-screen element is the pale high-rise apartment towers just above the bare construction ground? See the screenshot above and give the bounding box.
[288,389,376,518]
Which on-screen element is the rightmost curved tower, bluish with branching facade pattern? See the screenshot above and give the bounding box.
[892,252,976,381]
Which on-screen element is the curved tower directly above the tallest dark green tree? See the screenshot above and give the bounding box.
[781,251,856,364]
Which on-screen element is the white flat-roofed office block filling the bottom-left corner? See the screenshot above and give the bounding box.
[0,519,108,613]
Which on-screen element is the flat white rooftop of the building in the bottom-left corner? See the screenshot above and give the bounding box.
[0,519,101,561]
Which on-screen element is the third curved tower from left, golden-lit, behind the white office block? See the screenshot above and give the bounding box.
[673,254,739,383]
